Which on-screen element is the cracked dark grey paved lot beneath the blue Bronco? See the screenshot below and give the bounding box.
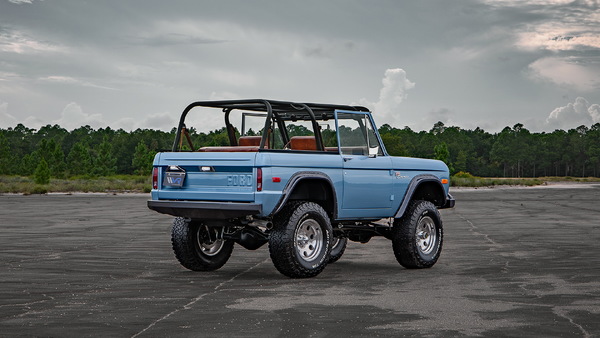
[0,185,600,337]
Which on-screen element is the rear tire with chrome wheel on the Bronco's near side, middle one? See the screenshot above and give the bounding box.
[269,201,333,278]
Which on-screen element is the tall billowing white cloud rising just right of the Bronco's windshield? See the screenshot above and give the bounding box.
[359,68,415,125]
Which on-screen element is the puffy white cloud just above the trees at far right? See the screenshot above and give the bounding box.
[546,97,600,130]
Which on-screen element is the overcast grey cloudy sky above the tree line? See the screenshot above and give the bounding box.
[0,0,600,132]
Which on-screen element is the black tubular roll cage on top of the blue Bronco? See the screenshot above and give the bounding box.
[173,99,369,151]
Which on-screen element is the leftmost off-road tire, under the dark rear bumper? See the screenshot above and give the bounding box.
[171,217,234,271]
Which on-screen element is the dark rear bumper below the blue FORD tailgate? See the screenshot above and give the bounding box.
[148,200,262,219]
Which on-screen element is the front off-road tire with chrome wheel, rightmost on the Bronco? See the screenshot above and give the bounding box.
[392,200,444,269]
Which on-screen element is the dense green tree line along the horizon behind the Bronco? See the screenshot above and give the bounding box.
[0,122,600,181]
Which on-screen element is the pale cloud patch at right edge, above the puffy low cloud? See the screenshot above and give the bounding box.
[529,57,600,91]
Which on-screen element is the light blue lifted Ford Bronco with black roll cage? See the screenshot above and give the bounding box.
[148,99,454,278]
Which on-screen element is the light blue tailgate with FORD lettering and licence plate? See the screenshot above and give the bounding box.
[152,152,257,202]
